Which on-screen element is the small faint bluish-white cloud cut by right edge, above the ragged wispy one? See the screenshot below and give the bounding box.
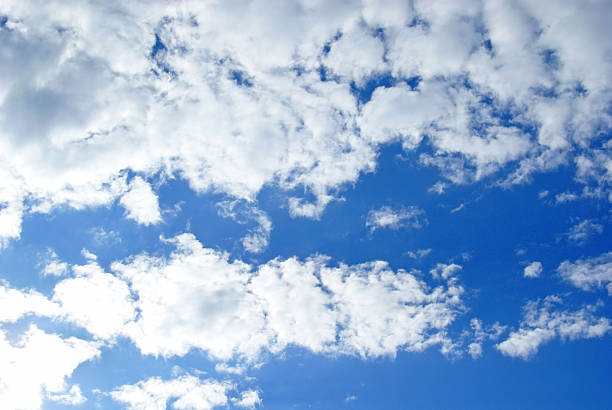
[557,252,612,295]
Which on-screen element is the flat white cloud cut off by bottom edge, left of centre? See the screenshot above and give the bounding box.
[110,375,232,410]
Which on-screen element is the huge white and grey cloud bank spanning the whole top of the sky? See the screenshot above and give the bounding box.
[0,0,612,250]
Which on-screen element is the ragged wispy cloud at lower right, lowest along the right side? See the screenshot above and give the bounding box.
[495,296,612,360]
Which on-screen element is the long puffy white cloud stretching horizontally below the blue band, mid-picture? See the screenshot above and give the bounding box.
[112,234,463,361]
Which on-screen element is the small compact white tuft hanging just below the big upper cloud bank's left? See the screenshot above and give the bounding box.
[119,176,162,225]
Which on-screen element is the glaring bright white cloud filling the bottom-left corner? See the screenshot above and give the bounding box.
[0,325,100,409]
